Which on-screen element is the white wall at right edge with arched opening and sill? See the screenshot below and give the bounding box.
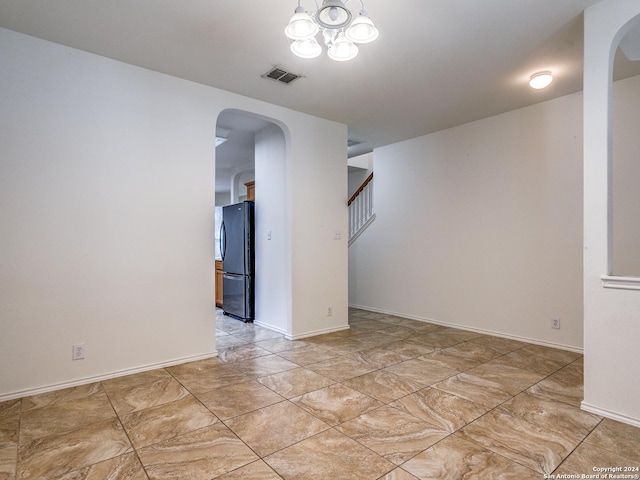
[582,0,640,426]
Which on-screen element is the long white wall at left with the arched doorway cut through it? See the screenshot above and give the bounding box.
[0,29,347,400]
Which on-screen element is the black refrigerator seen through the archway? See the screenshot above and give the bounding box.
[220,201,255,322]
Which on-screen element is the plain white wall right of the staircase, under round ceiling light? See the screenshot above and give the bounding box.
[349,89,583,350]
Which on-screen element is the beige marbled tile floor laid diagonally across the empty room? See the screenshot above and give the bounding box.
[0,310,640,480]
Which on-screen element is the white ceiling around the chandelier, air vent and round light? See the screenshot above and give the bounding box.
[0,0,640,163]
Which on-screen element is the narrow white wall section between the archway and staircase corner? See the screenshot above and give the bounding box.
[287,117,349,338]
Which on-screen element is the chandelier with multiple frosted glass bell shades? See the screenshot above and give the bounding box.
[284,0,378,62]
